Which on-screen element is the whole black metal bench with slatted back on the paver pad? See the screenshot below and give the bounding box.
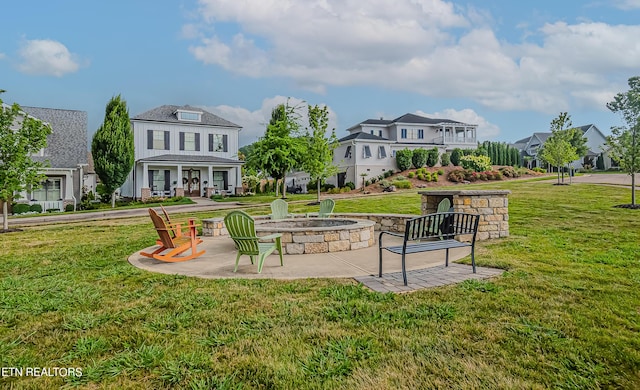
[378,212,480,286]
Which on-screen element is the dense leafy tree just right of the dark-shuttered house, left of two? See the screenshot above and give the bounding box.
[247,102,303,198]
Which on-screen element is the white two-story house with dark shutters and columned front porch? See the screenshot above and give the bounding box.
[121,105,242,200]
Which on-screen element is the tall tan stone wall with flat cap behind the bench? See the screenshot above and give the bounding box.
[419,190,511,240]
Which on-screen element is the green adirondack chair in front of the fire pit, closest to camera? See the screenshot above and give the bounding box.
[224,210,283,273]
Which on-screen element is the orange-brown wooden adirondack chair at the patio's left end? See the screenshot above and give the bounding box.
[140,209,205,263]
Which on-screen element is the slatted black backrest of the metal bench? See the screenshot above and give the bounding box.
[404,212,480,242]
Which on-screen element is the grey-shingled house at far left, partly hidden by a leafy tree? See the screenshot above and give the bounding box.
[18,106,96,211]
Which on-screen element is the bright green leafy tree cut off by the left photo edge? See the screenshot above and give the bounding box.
[0,90,51,230]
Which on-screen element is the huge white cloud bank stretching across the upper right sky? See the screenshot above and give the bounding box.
[191,0,640,114]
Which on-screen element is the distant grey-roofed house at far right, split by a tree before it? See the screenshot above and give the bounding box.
[513,124,612,169]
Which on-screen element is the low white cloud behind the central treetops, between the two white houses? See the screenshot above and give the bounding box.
[202,96,337,145]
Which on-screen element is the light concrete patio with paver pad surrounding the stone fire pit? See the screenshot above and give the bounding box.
[129,235,503,292]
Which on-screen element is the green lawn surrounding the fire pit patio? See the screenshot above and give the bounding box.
[0,182,640,389]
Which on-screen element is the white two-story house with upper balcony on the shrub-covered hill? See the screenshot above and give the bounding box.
[327,114,478,188]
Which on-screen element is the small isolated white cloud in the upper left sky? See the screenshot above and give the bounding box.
[18,39,80,77]
